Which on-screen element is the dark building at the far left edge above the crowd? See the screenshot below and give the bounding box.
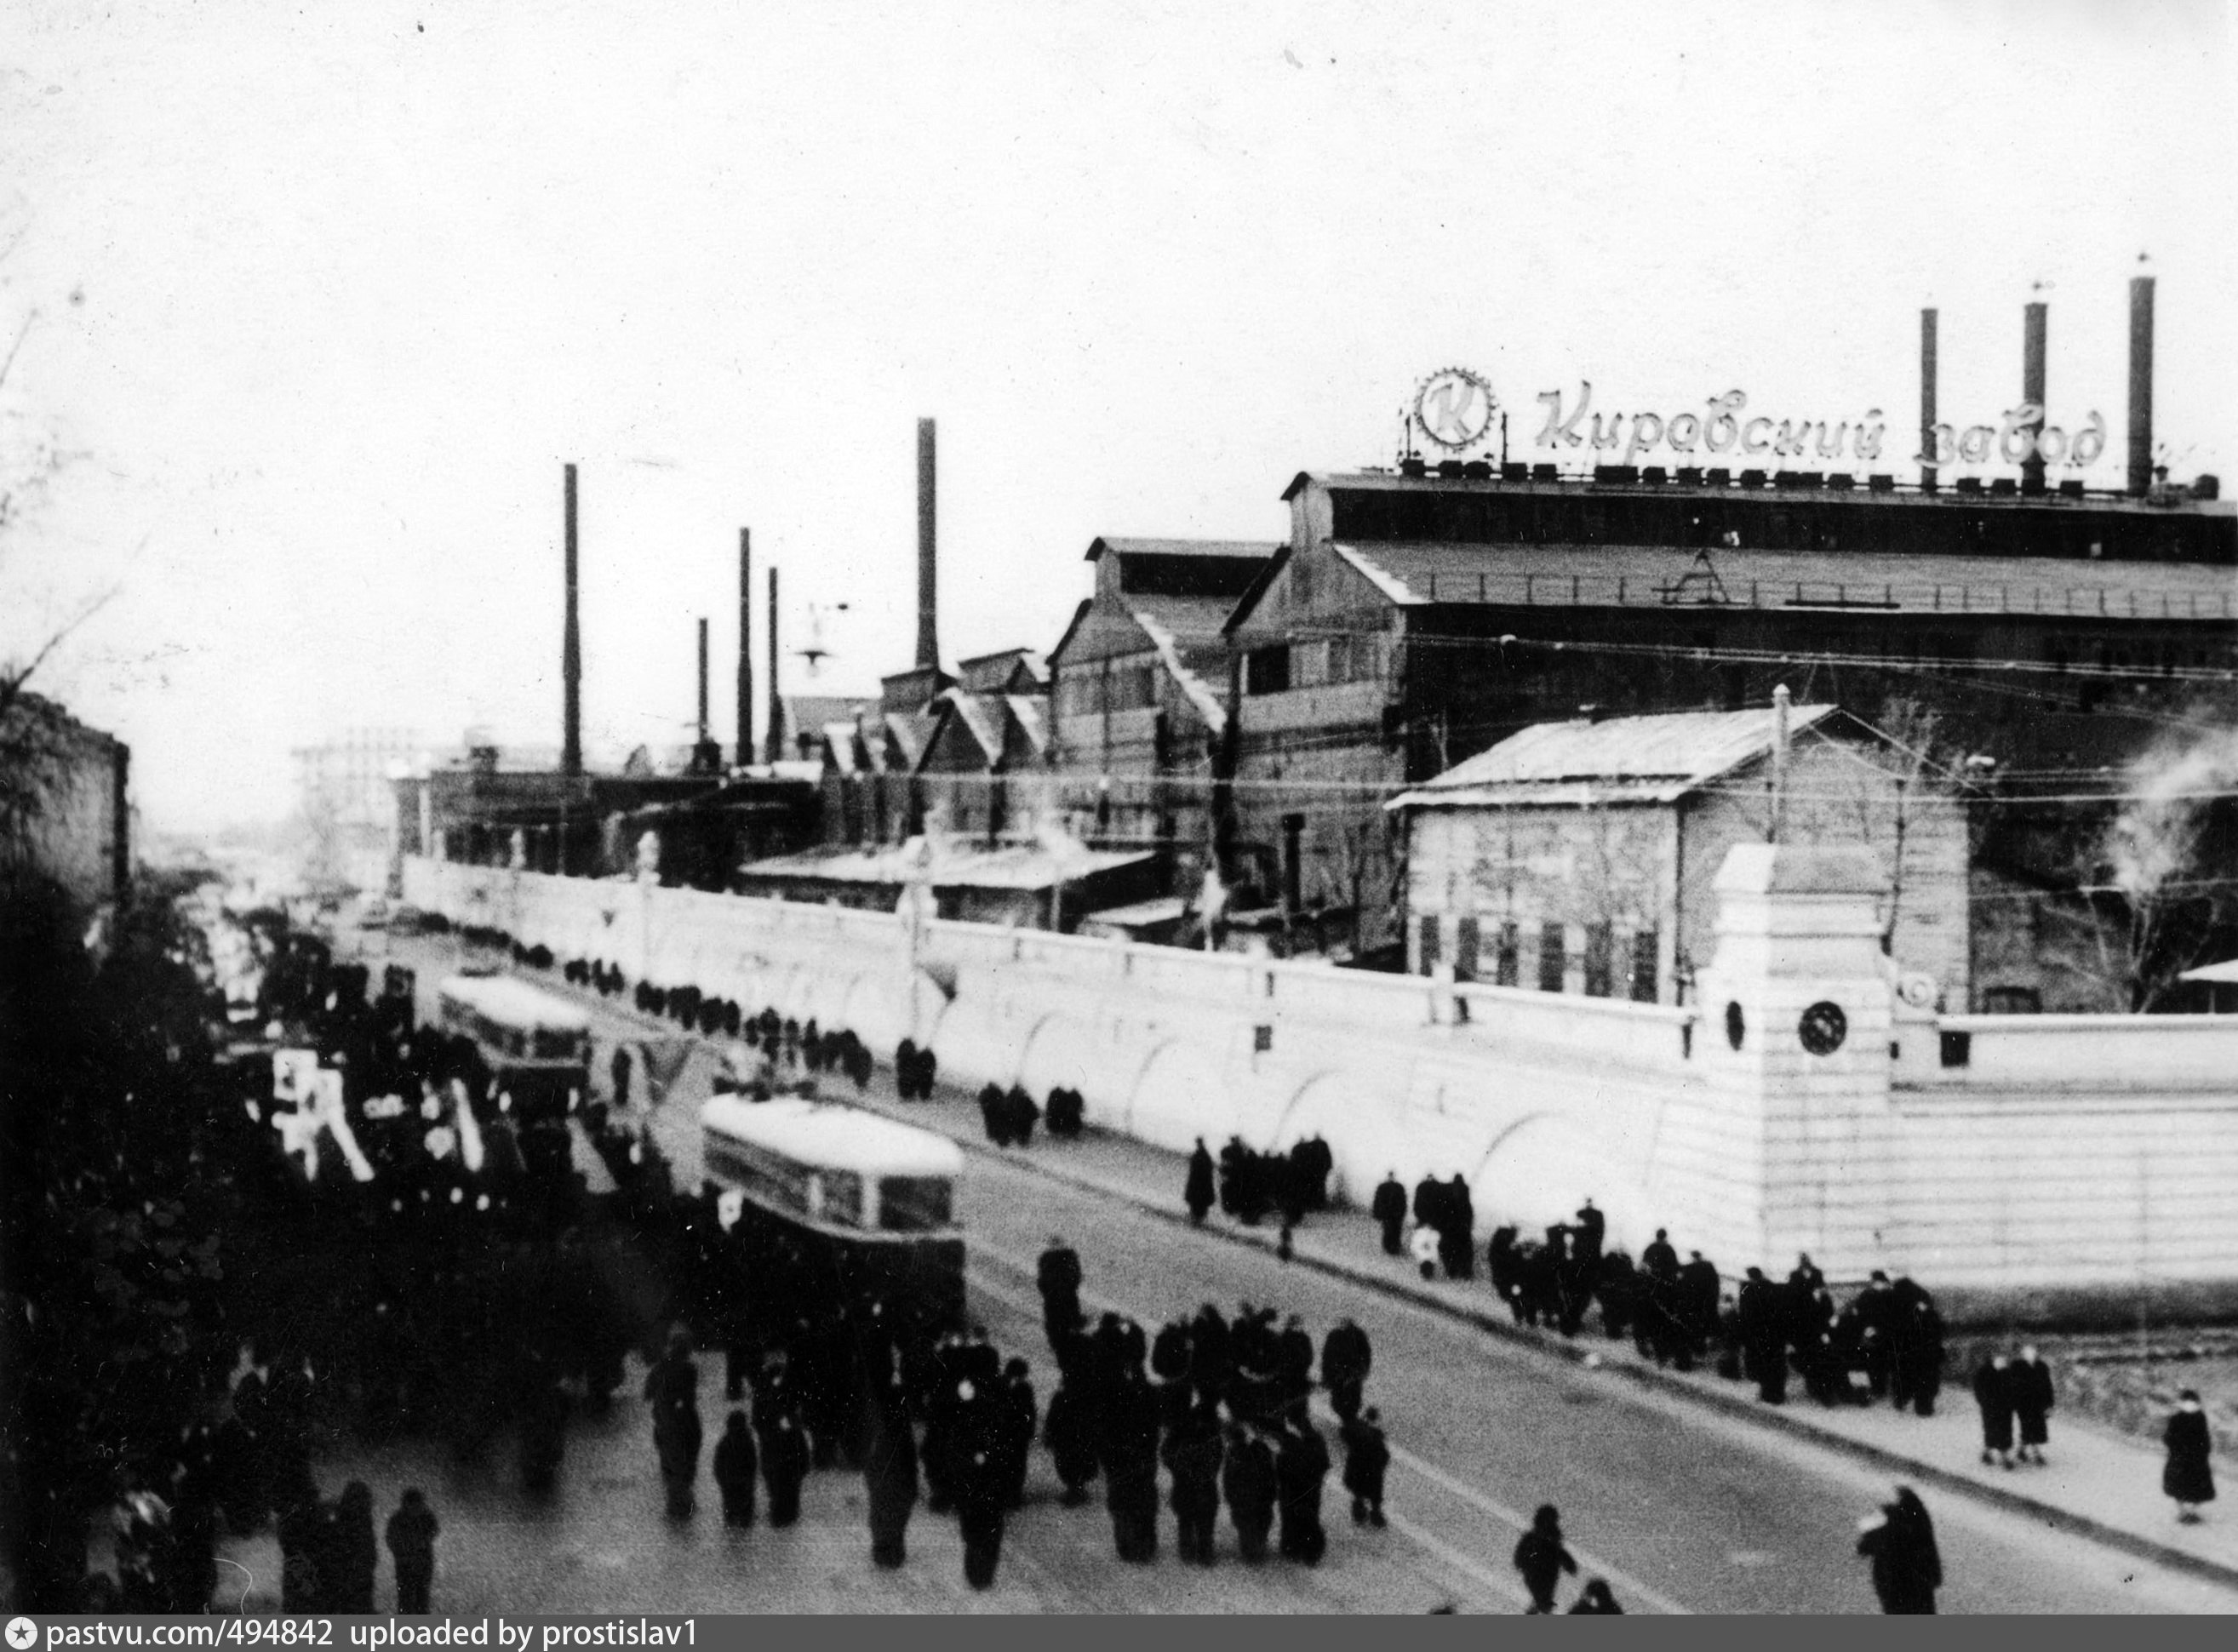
[0,692,132,917]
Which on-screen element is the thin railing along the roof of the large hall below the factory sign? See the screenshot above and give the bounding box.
[1426,573,2238,620]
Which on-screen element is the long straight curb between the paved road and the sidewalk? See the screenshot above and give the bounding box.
[942,1126,2238,1585]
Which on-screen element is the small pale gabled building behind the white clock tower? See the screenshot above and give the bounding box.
[1388,705,1970,1009]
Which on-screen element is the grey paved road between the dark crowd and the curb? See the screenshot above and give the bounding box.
[362,926,2238,1612]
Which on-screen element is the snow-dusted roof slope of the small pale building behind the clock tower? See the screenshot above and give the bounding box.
[1385,705,1837,808]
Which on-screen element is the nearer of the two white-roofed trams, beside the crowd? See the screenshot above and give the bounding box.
[701,1095,964,1332]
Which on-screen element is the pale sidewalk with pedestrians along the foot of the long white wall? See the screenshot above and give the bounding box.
[830,1086,2238,1582]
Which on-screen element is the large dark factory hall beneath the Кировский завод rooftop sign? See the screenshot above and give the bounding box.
[1226,461,2238,947]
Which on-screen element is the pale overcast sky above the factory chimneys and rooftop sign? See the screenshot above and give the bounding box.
[0,0,2238,826]
